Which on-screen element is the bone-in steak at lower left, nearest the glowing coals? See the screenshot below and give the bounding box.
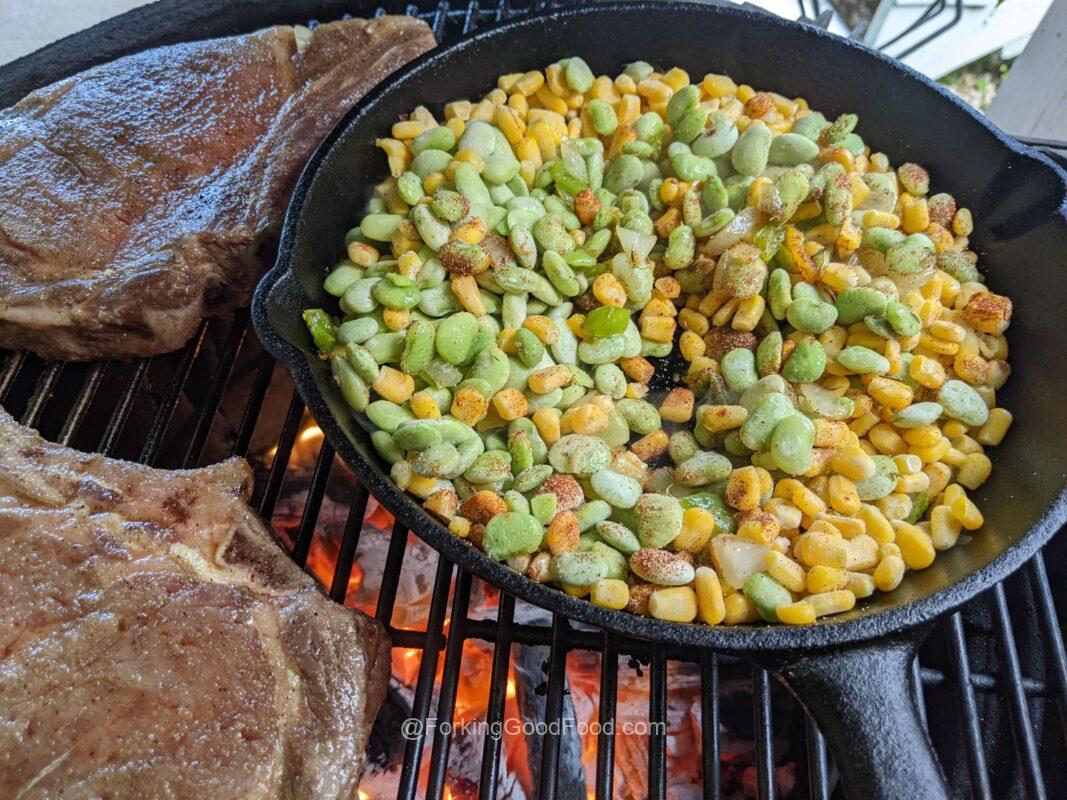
[0,411,389,800]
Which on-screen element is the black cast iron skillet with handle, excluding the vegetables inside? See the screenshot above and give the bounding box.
[253,2,1067,800]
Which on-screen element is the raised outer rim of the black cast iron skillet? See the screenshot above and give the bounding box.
[252,0,1067,654]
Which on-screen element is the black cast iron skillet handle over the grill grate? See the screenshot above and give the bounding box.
[776,630,950,800]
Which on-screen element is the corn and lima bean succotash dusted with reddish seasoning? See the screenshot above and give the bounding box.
[305,58,1012,625]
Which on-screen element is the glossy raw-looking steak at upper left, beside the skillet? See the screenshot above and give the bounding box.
[0,17,434,361]
